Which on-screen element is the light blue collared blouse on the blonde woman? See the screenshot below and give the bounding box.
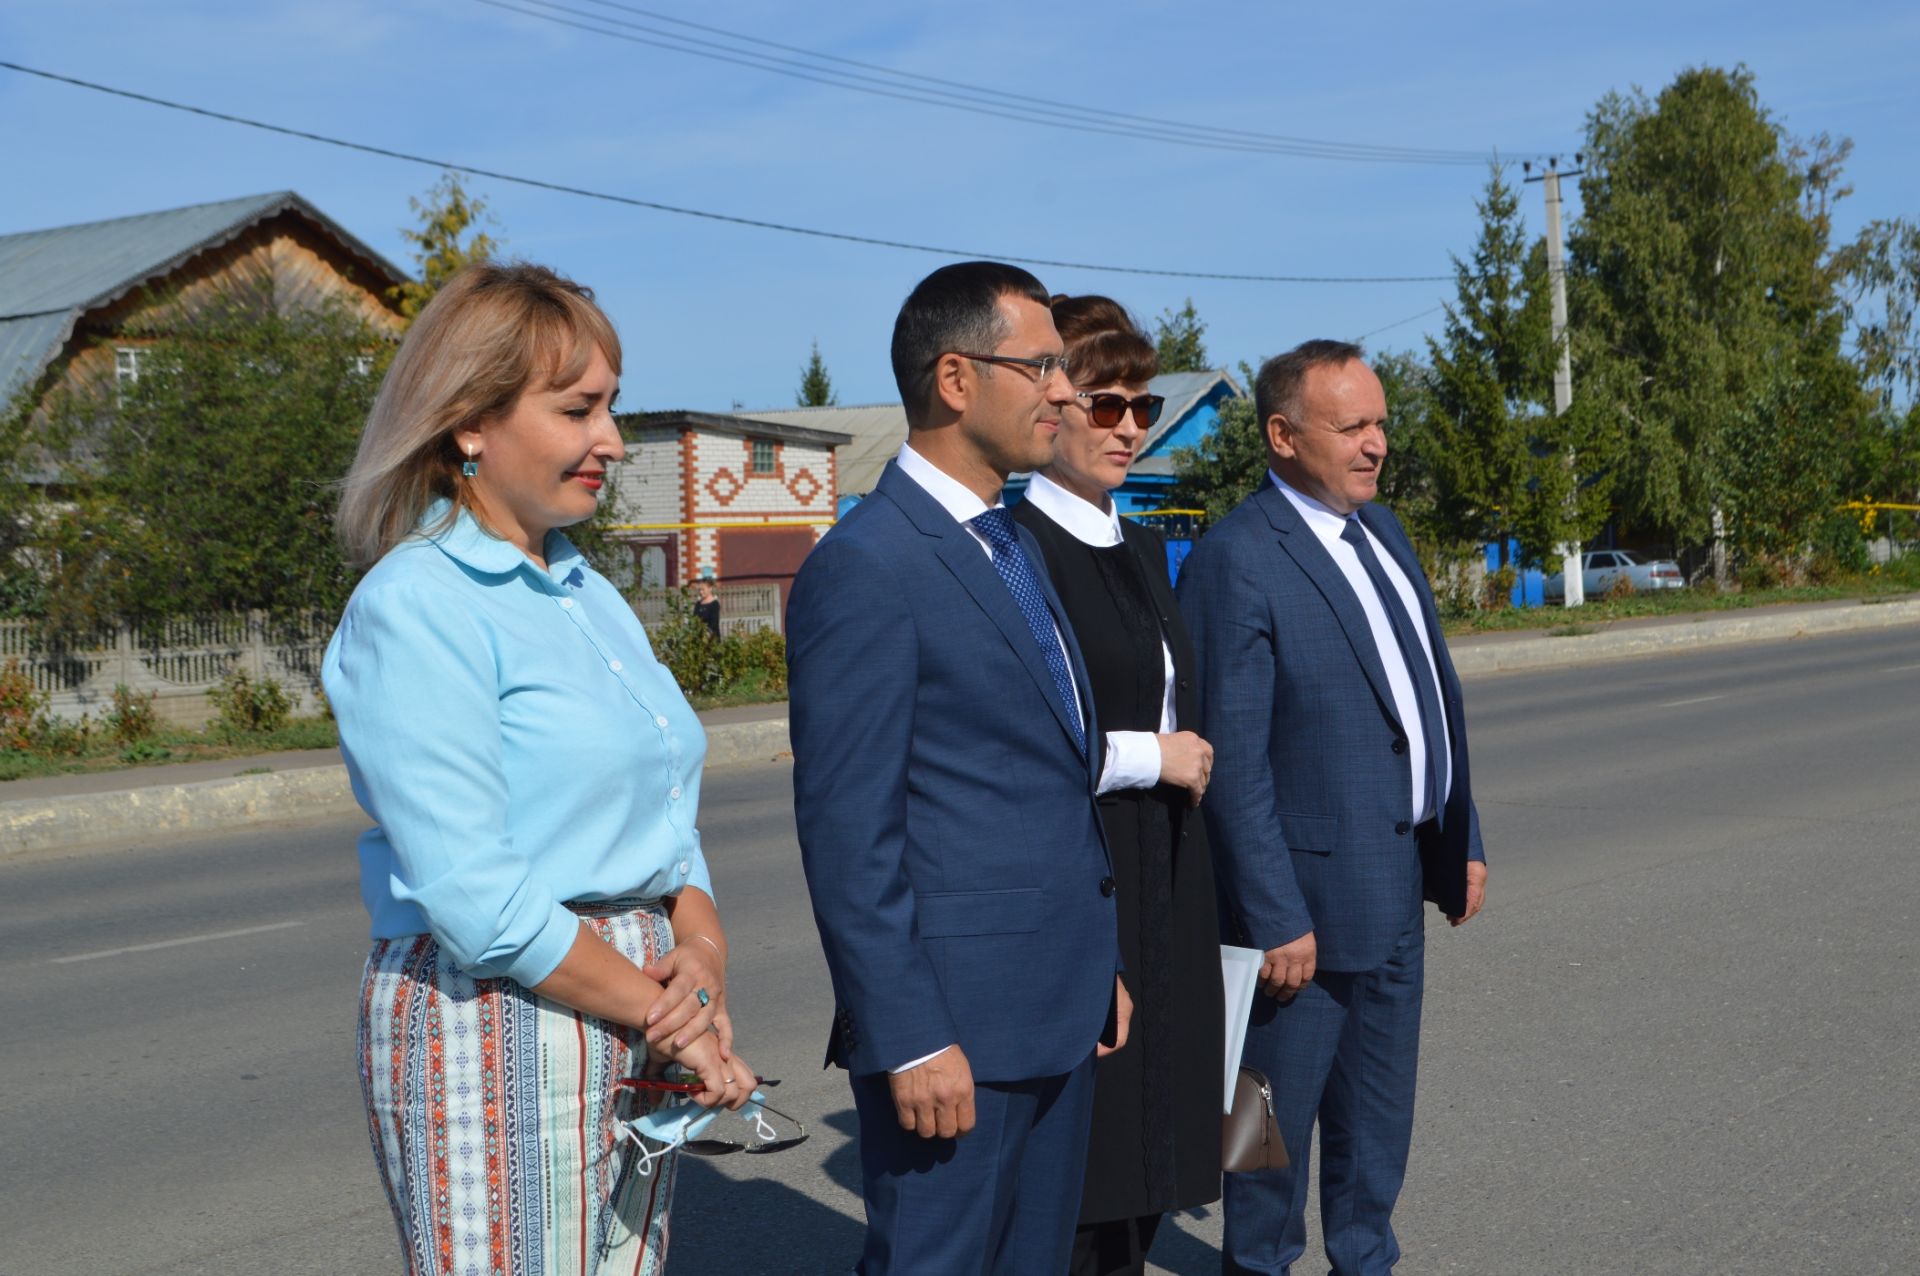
[321,503,712,984]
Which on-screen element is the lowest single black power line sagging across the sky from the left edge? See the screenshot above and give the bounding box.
[0,59,1452,284]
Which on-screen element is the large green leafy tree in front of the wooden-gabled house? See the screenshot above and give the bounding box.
[36,290,390,631]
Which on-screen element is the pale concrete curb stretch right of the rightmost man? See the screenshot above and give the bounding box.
[1450,601,1920,677]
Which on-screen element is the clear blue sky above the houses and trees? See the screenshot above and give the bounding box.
[0,0,1920,409]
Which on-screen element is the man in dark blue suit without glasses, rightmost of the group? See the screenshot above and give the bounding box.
[1179,342,1486,1276]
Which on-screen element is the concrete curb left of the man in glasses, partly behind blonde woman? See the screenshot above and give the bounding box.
[0,718,789,858]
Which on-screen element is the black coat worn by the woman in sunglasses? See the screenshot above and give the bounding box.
[1014,501,1225,1222]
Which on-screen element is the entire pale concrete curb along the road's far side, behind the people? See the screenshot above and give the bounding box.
[0,601,1920,858]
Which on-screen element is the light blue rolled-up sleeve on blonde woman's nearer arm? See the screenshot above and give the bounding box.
[323,585,576,984]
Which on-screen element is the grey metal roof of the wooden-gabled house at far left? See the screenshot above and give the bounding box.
[0,190,407,402]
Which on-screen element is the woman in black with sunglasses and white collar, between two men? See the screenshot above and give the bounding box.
[1014,297,1223,1276]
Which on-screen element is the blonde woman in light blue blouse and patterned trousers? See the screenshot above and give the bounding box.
[323,265,755,1274]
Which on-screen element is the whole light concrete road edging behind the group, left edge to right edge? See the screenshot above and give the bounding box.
[0,597,1920,858]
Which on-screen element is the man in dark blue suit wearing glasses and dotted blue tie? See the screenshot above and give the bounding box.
[787,261,1131,1276]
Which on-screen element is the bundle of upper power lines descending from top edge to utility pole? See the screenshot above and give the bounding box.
[474,0,1492,165]
